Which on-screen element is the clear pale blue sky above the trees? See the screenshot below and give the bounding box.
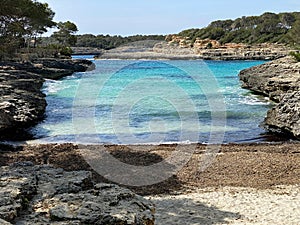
[39,0,300,36]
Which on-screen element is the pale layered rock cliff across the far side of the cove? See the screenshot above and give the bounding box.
[98,35,290,60]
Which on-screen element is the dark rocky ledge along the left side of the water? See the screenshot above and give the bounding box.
[0,59,93,139]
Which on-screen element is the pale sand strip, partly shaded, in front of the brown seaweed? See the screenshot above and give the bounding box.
[148,186,300,225]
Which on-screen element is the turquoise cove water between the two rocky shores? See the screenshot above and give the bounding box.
[31,60,271,144]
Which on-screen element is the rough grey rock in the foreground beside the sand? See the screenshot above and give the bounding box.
[0,162,155,225]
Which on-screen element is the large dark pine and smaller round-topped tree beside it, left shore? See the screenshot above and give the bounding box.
[0,0,77,58]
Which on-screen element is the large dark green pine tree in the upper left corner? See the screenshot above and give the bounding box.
[0,0,55,55]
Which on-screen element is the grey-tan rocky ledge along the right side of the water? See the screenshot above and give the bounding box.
[239,57,300,139]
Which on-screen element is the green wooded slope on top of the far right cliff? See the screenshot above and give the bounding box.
[179,12,300,47]
